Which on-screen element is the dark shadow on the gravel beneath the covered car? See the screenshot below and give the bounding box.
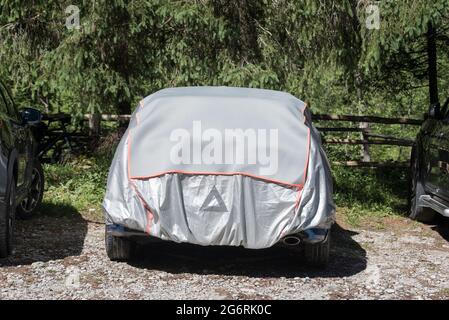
[130,225,366,278]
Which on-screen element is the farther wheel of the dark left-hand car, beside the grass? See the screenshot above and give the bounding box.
[17,160,44,219]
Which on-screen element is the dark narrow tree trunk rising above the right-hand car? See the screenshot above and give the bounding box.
[427,22,439,104]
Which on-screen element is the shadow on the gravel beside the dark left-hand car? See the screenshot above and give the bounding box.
[0,203,87,266]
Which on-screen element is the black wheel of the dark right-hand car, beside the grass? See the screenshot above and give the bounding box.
[409,148,435,222]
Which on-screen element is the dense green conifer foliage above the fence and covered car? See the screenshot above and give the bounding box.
[0,0,449,115]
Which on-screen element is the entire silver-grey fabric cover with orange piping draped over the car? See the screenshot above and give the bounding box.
[103,87,335,249]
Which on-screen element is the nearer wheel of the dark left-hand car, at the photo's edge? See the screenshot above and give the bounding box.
[0,178,16,258]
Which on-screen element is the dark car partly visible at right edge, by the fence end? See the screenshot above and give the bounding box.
[410,99,449,222]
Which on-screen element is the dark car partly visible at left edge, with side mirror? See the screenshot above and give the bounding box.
[0,82,44,258]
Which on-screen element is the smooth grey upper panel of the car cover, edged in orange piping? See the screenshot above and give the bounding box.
[128,87,310,187]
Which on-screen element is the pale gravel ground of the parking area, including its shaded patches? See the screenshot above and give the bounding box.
[0,212,449,299]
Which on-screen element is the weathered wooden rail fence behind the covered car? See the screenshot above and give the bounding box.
[46,114,423,167]
